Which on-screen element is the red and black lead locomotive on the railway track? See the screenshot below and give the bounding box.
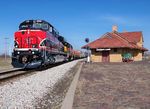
[12,20,74,68]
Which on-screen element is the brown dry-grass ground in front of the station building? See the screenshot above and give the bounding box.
[73,61,150,109]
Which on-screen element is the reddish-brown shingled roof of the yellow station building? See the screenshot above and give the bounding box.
[82,32,147,51]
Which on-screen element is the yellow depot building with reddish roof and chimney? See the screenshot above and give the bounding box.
[82,26,147,62]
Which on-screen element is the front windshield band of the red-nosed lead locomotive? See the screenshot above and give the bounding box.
[19,22,48,31]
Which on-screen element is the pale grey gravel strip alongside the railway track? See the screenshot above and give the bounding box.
[0,60,78,109]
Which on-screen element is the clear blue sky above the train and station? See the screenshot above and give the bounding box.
[0,0,150,54]
